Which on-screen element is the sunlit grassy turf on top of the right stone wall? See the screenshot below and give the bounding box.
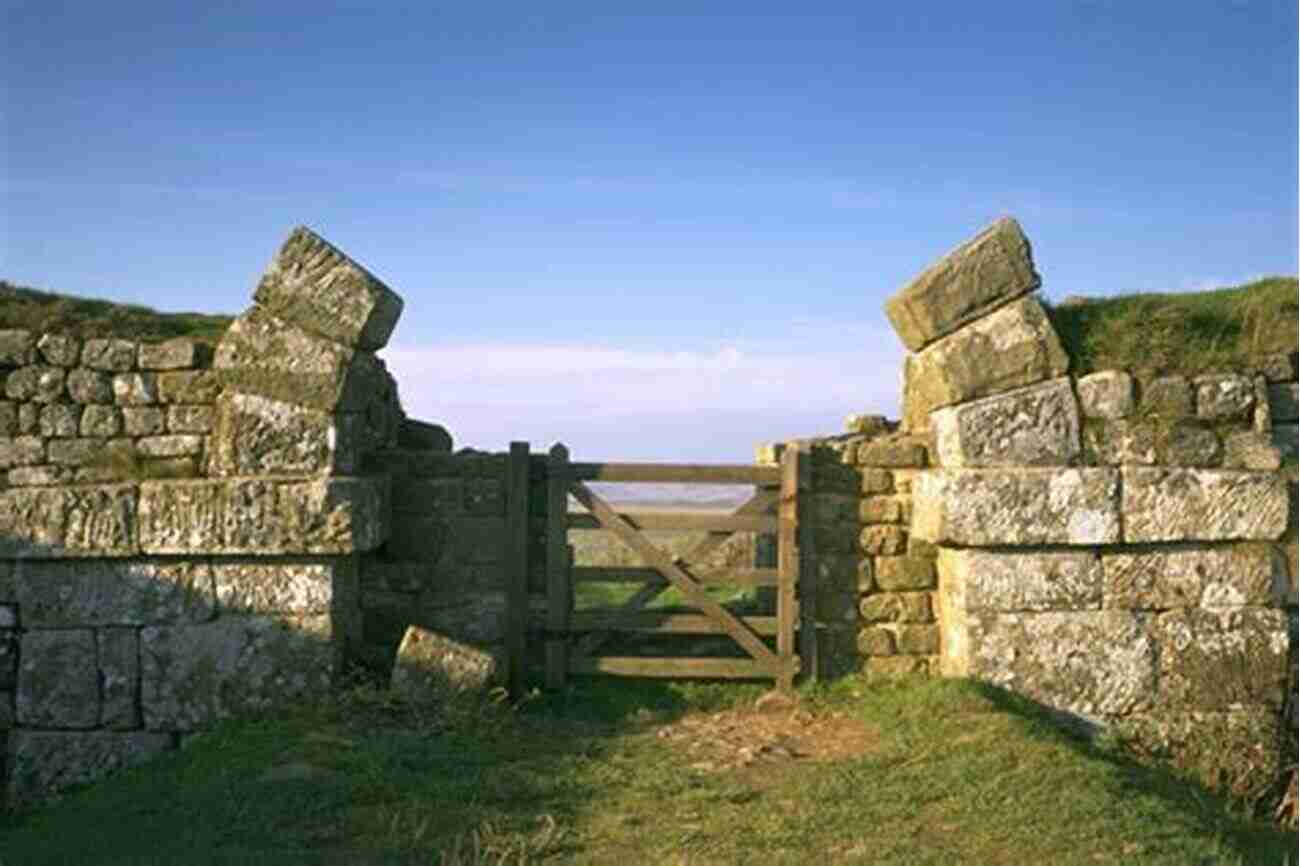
[1048,277,1297,376]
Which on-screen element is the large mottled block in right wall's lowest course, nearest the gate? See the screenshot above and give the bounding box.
[961,610,1157,722]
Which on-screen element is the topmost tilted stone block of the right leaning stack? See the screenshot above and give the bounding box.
[885,218,1043,351]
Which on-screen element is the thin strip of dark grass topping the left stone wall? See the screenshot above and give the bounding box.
[0,280,231,345]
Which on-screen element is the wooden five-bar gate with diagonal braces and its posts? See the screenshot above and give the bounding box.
[507,442,816,693]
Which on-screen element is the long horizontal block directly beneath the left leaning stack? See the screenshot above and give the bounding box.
[139,477,389,555]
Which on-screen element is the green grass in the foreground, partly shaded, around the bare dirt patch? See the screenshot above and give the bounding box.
[0,677,1295,866]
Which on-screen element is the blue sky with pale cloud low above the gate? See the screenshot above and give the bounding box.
[0,0,1297,460]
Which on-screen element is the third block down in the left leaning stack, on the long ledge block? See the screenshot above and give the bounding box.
[212,393,358,476]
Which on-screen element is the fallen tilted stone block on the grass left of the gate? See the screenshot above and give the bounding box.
[391,625,503,698]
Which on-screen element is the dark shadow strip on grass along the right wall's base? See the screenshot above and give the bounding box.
[967,680,1296,865]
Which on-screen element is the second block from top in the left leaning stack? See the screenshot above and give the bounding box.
[212,307,393,412]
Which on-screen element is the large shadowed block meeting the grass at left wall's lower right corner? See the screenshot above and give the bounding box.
[140,614,342,731]
